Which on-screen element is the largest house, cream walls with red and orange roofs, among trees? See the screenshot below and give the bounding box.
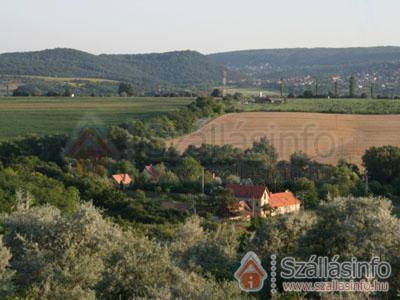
[226,184,301,217]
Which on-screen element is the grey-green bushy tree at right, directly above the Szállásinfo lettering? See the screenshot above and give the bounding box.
[299,197,400,299]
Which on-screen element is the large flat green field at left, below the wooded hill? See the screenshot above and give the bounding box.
[0,97,193,140]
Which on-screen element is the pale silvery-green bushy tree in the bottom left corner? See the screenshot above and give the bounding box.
[2,204,120,299]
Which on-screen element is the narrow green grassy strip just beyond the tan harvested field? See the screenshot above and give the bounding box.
[236,99,400,114]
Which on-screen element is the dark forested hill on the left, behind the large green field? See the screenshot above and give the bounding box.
[0,48,233,87]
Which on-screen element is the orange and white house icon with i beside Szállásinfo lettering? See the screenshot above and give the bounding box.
[235,251,267,292]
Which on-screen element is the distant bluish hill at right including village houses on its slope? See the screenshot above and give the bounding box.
[208,47,400,94]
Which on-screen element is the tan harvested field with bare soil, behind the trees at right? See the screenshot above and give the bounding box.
[172,112,400,164]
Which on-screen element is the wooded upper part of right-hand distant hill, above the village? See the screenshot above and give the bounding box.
[209,47,400,78]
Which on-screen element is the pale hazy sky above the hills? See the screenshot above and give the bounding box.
[0,0,400,53]
